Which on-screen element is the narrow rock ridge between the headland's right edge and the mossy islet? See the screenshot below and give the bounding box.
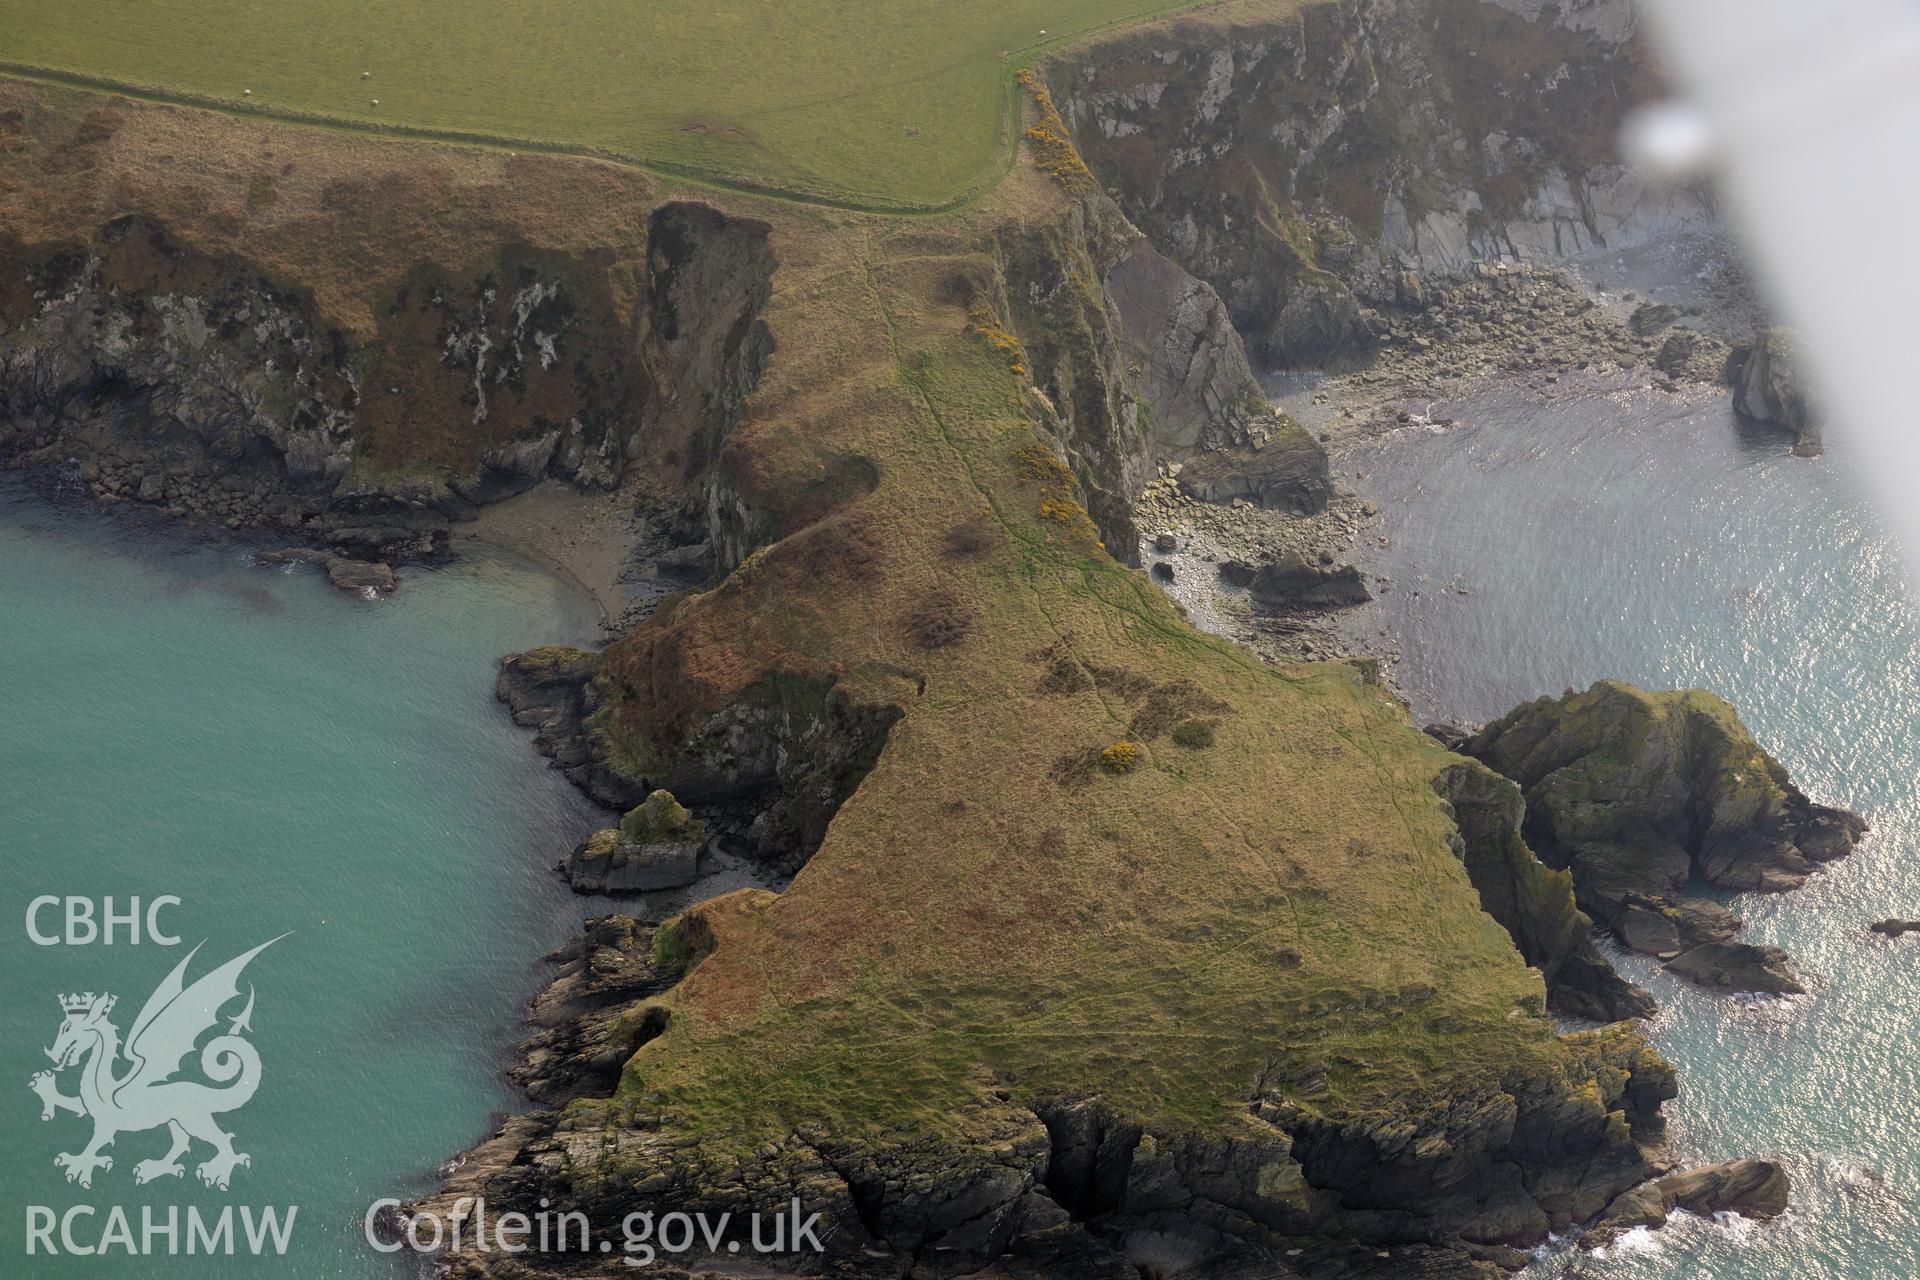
[1434,762,1655,1023]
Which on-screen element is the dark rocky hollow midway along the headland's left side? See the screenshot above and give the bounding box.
[495,631,900,871]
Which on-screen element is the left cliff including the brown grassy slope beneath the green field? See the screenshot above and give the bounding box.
[0,83,780,558]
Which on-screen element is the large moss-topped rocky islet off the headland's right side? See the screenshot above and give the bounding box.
[1457,681,1866,992]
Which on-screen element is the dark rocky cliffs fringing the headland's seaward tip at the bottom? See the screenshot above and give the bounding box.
[424,890,1678,1280]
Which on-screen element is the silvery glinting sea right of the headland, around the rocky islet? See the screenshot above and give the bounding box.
[1340,391,1920,1280]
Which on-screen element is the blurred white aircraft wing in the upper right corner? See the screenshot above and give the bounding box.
[1644,0,1920,566]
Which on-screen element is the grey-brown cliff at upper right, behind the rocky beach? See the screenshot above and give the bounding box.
[1048,0,1713,367]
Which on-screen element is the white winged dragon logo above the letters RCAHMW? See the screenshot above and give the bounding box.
[27,935,286,1192]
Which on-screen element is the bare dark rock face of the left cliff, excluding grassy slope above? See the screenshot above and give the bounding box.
[0,203,774,557]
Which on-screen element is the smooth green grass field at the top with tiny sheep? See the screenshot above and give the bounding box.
[0,0,1192,209]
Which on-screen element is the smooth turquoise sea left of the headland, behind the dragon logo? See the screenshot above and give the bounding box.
[0,478,595,1280]
